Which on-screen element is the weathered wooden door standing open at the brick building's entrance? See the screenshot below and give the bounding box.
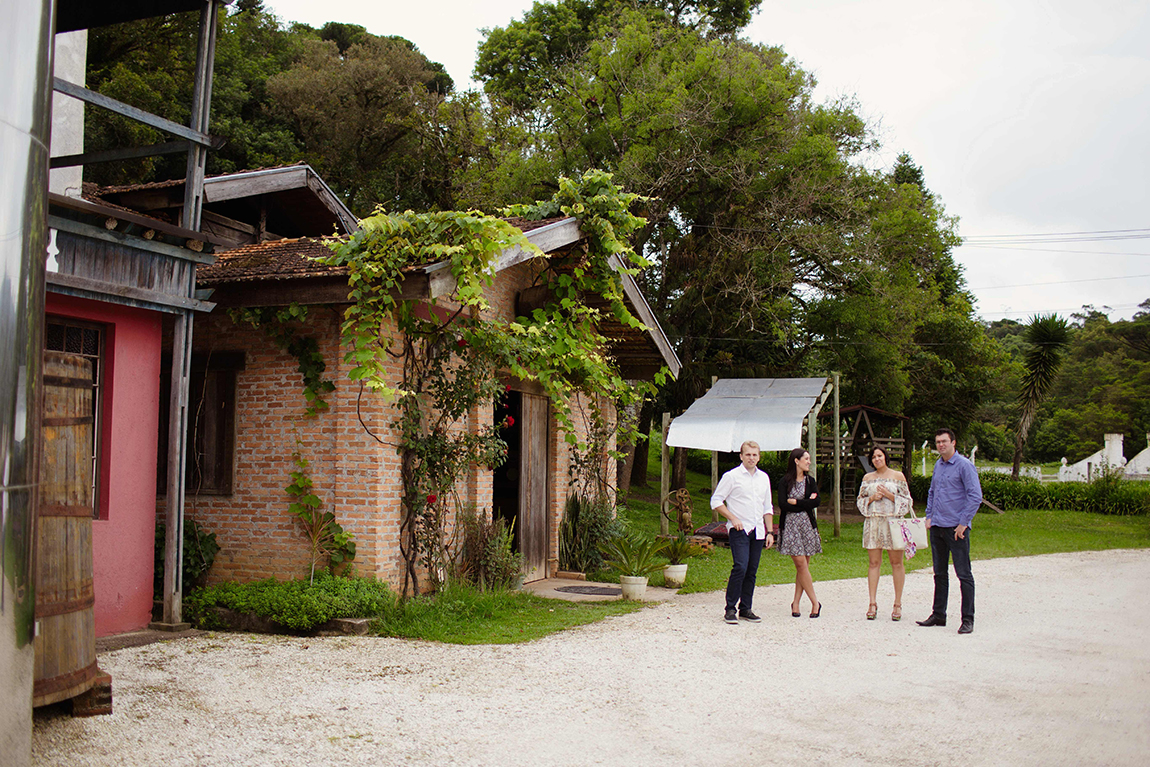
[519,394,551,581]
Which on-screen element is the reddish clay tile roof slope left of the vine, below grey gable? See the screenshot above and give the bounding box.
[196,237,347,285]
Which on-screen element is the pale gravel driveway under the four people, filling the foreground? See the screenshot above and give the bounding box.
[31,551,1150,767]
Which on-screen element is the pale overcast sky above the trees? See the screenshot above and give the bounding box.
[265,0,1150,321]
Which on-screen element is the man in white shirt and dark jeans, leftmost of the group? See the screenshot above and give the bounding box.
[711,440,775,623]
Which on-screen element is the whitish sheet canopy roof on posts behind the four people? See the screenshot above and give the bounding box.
[667,378,833,453]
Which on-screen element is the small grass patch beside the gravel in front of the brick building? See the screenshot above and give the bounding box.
[371,584,648,644]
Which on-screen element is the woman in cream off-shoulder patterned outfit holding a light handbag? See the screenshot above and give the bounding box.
[856,446,911,621]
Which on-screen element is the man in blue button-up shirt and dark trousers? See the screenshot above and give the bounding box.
[918,429,982,634]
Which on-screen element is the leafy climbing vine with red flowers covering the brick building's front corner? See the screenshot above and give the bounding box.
[323,171,664,593]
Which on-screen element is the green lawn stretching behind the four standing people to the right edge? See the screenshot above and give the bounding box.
[611,462,1150,593]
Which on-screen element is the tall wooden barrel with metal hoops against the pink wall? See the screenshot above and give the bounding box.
[32,352,99,706]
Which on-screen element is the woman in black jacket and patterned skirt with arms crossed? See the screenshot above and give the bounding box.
[777,447,822,618]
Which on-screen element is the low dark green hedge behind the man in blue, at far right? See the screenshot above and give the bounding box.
[911,475,1150,515]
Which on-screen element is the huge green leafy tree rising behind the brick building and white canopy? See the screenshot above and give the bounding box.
[465,0,996,443]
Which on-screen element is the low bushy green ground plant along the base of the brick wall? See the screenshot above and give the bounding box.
[184,570,396,631]
